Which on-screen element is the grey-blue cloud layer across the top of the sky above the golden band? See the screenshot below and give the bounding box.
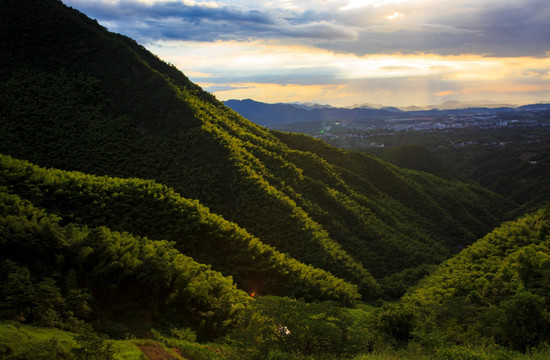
[66,0,550,56]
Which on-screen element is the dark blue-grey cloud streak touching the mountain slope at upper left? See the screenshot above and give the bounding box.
[66,0,356,41]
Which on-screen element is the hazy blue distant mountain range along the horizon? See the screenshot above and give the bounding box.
[224,99,550,127]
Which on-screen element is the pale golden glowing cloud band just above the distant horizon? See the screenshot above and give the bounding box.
[149,41,550,106]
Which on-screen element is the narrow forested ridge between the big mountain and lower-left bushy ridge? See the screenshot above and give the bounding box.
[0,155,362,304]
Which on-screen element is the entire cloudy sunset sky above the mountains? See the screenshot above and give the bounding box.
[63,0,550,107]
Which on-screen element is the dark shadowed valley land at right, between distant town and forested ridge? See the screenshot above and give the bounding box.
[358,126,550,214]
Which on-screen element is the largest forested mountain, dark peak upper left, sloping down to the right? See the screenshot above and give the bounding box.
[0,0,510,298]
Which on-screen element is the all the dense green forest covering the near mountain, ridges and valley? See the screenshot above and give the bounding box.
[0,0,550,359]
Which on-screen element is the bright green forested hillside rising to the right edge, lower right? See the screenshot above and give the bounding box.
[403,208,550,351]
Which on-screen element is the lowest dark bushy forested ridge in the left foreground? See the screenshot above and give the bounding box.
[0,189,250,337]
